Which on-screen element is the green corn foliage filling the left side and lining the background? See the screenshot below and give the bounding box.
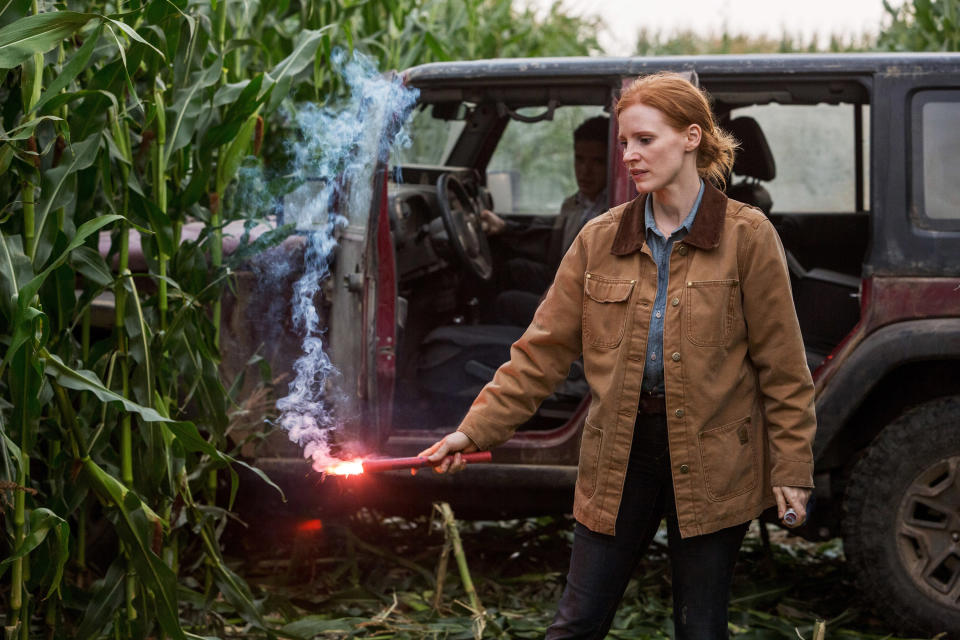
[0,0,960,638]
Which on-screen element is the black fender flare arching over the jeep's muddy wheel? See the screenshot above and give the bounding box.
[813,318,960,461]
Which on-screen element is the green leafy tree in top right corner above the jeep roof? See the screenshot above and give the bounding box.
[877,0,960,51]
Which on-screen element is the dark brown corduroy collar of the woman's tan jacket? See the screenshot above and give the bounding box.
[610,181,727,256]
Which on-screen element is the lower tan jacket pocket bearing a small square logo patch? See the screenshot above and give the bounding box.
[699,417,757,502]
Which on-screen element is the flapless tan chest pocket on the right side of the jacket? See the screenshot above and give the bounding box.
[686,280,740,347]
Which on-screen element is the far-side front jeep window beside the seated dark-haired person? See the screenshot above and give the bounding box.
[487,106,605,216]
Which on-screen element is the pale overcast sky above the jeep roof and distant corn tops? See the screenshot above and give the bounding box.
[526,0,903,55]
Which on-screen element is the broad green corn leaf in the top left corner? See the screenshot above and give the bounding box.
[0,11,98,69]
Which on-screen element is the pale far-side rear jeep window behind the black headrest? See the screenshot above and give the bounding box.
[730,103,870,213]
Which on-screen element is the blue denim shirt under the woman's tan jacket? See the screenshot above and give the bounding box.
[641,180,703,393]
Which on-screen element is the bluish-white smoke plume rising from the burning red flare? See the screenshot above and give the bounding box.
[277,51,418,470]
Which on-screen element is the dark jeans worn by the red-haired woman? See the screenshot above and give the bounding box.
[546,415,749,640]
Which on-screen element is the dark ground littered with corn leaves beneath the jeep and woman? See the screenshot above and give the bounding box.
[223,511,928,640]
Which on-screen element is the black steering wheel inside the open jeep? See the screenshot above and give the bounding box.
[437,173,493,280]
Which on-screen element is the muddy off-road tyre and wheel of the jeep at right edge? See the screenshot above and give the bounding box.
[843,396,960,633]
